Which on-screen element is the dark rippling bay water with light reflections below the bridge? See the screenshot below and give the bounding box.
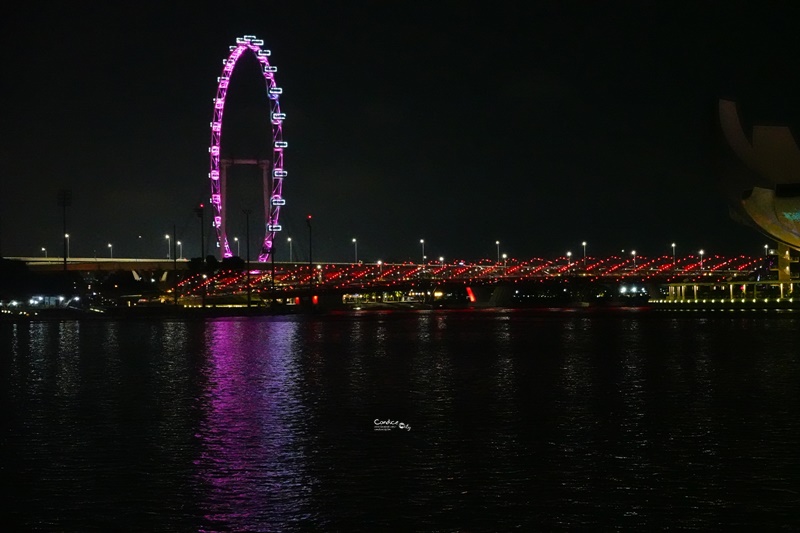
[0,311,800,532]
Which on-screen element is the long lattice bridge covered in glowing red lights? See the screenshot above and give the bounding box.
[167,252,766,302]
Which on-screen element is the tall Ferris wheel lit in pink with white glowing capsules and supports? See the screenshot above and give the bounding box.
[208,35,287,262]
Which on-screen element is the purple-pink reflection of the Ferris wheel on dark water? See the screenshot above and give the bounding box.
[195,319,308,531]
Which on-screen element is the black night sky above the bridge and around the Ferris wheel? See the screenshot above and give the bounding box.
[0,1,800,261]
